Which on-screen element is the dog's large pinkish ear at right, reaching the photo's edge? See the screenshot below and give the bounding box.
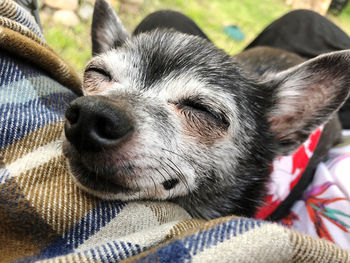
[265,50,350,154]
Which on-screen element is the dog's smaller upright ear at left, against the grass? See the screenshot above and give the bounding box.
[91,0,130,56]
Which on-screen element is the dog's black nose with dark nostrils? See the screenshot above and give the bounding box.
[64,96,133,151]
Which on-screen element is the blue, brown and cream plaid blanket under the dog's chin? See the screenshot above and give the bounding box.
[0,0,350,262]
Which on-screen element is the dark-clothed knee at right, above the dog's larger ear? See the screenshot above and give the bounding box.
[246,10,350,59]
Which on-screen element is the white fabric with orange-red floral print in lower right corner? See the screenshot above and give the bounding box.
[282,131,350,250]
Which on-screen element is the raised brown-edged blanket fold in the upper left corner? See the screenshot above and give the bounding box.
[0,0,82,95]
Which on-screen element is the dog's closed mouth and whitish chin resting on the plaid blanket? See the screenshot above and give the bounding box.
[63,141,188,201]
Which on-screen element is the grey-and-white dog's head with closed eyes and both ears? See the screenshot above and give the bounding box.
[64,0,350,218]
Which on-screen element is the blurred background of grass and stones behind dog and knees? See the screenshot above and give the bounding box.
[39,0,350,74]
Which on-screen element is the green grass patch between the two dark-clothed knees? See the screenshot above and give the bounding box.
[133,0,289,54]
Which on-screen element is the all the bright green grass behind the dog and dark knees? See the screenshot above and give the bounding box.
[42,0,350,73]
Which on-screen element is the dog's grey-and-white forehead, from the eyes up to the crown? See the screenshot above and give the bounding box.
[91,31,247,116]
